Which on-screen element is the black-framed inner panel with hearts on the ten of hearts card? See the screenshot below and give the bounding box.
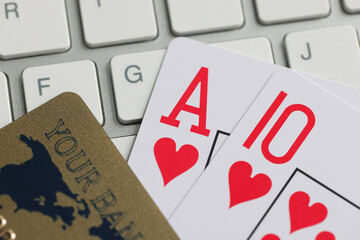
[250,169,360,240]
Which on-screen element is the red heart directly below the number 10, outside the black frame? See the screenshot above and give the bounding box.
[229,161,271,208]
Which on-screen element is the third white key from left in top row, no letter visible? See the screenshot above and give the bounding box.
[167,0,244,35]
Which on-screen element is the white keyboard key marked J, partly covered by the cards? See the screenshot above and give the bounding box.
[285,26,360,88]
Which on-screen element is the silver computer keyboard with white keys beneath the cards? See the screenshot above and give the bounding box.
[0,0,360,160]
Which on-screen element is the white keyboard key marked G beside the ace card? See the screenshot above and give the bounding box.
[111,50,165,124]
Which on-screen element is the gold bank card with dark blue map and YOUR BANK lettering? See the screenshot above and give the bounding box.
[0,93,178,240]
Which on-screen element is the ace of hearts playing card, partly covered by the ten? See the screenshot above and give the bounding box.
[129,38,360,217]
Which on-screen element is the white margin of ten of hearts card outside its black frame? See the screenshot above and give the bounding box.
[170,70,360,239]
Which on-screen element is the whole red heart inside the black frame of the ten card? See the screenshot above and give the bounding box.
[289,191,327,233]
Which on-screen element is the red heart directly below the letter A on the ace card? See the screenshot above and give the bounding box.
[154,138,199,187]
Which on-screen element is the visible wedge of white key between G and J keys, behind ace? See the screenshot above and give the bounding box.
[211,37,274,63]
